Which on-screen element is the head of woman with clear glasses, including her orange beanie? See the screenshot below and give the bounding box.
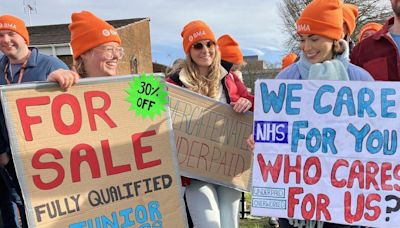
[68,11,124,77]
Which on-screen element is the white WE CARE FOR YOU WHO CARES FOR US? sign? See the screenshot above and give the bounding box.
[252,80,400,227]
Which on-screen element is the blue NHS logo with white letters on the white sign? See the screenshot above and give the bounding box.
[254,121,288,143]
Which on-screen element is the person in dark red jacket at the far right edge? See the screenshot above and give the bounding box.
[351,0,400,81]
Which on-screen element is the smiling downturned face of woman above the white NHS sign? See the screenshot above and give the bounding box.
[299,34,333,64]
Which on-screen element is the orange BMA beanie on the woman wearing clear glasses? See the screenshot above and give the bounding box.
[68,11,121,59]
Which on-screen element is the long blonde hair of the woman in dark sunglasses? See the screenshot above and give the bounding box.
[171,45,221,98]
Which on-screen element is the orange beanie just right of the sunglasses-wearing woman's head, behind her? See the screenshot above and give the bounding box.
[217,35,243,64]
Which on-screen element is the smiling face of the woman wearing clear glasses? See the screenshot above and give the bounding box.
[81,42,124,77]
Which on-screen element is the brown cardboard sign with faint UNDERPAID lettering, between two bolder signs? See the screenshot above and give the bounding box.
[168,85,252,191]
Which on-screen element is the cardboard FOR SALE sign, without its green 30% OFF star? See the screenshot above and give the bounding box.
[1,76,187,228]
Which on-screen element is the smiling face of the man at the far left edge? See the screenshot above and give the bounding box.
[0,30,29,63]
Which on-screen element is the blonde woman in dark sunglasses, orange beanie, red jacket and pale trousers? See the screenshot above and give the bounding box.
[167,20,254,228]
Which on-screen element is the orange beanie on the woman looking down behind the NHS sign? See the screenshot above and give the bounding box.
[296,0,343,40]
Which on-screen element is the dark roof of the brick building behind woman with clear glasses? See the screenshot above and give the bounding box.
[27,18,148,46]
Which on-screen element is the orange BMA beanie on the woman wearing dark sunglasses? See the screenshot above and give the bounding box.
[181,20,216,54]
